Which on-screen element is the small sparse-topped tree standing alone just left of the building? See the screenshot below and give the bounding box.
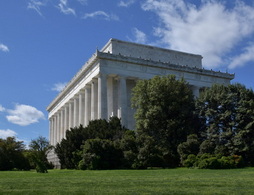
[29,136,53,173]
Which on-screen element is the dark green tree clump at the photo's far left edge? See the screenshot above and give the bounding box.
[0,137,30,170]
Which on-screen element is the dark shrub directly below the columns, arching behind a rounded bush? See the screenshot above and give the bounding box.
[55,117,126,169]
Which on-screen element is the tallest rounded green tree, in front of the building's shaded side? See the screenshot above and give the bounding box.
[132,75,198,167]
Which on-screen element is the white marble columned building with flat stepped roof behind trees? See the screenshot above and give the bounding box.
[47,39,234,165]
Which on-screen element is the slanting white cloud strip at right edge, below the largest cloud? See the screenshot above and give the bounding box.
[229,45,254,69]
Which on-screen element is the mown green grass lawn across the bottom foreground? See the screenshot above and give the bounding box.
[0,168,254,194]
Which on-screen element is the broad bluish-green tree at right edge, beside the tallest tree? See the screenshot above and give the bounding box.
[196,84,254,165]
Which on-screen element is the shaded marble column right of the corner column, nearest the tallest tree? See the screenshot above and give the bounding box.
[118,76,128,127]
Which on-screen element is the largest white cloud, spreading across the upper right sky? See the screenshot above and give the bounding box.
[142,0,254,68]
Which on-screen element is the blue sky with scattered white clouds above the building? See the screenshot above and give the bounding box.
[0,0,254,144]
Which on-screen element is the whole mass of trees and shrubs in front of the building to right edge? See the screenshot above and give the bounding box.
[55,79,254,169]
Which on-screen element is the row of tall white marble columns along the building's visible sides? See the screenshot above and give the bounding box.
[49,74,128,145]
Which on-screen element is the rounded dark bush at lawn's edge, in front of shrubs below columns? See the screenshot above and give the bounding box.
[79,139,123,170]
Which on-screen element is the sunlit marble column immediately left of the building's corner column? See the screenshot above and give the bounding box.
[91,78,98,120]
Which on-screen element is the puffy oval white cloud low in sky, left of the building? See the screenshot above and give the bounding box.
[6,104,45,126]
